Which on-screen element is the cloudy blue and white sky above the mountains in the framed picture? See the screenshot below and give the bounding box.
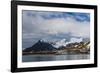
[22,10,90,48]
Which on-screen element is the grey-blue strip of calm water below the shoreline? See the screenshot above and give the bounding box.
[22,54,90,62]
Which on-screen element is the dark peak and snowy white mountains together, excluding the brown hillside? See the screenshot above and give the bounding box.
[23,38,87,52]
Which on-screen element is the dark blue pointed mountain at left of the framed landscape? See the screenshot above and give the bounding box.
[23,40,56,52]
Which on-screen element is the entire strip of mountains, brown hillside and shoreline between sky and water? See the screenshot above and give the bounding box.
[23,38,90,55]
